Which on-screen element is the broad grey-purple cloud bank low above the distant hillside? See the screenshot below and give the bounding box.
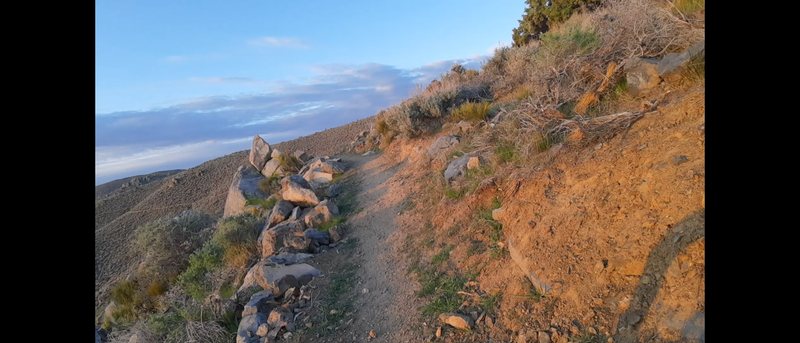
[95,56,488,183]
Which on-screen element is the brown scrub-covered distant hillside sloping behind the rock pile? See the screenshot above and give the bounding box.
[95,116,375,301]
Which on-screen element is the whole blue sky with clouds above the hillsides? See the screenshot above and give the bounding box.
[95,0,525,185]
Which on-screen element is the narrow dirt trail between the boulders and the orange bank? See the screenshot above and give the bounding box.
[324,155,418,342]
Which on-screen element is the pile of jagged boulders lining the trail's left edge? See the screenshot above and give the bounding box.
[225,132,354,343]
